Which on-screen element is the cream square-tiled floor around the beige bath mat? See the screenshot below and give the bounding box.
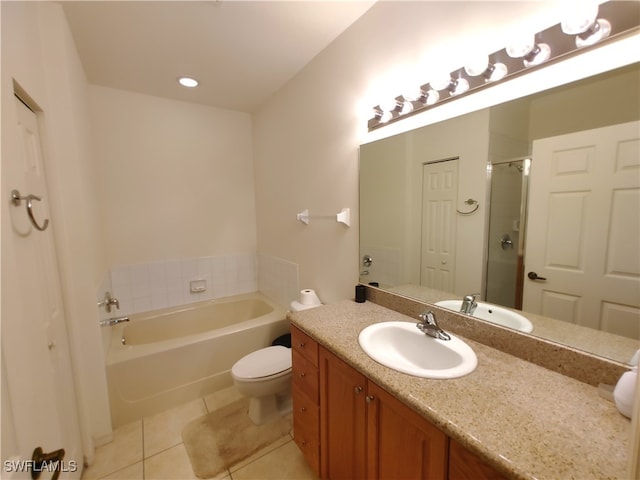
[82,387,317,480]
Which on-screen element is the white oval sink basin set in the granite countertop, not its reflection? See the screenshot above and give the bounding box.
[358,322,478,378]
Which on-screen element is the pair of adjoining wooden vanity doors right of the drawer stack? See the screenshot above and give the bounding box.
[319,347,448,479]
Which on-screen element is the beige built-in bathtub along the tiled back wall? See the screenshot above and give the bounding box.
[106,293,289,428]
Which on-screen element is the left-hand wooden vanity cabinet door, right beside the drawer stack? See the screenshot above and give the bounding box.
[319,347,366,480]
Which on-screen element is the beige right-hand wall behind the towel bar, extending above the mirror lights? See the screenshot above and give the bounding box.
[253,2,568,302]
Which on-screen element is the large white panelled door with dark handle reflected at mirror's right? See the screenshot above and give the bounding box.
[523,122,640,338]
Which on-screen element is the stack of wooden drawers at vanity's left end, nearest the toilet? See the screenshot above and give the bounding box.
[291,326,320,474]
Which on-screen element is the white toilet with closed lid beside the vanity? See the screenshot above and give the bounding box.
[231,345,291,425]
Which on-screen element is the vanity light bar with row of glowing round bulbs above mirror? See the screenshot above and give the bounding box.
[368,1,640,131]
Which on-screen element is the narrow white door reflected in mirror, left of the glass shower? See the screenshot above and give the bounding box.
[420,159,458,292]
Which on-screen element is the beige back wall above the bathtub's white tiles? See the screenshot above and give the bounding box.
[89,86,256,266]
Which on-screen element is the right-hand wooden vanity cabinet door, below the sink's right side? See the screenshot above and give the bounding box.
[366,382,448,480]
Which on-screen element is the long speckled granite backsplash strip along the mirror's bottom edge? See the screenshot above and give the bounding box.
[367,286,630,387]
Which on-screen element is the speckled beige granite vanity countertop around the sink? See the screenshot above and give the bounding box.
[288,300,631,480]
